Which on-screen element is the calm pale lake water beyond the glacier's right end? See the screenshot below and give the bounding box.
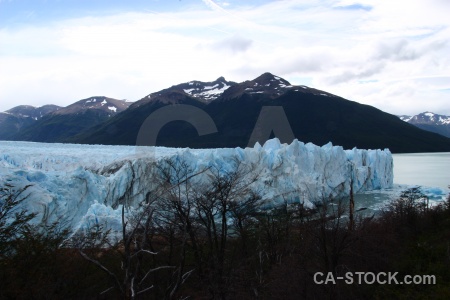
[392,152,450,189]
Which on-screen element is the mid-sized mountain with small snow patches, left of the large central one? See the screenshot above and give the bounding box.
[14,96,131,142]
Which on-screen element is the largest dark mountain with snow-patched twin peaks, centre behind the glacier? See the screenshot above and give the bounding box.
[67,73,450,153]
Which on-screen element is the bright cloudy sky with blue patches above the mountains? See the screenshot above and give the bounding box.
[0,0,450,115]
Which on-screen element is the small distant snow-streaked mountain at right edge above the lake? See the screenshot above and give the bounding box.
[399,111,450,138]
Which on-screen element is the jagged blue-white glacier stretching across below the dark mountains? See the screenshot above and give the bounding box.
[0,138,393,230]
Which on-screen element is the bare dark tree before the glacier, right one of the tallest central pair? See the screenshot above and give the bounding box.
[195,157,260,299]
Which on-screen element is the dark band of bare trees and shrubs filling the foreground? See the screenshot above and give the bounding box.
[0,158,450,299]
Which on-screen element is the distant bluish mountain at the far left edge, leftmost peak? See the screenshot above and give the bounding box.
[0,105,60,140]
